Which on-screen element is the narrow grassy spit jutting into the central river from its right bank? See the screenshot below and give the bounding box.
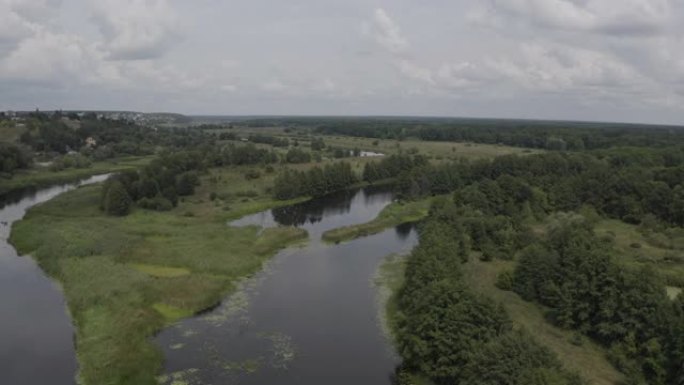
[322,198,433,243]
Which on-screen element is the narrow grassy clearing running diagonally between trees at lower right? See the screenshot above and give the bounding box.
[463,258,624,385]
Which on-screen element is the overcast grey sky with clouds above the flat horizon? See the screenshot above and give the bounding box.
[0,0,684,124]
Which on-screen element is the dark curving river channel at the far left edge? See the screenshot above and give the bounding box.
[0,175,107,385]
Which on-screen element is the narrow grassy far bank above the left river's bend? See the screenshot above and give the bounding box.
[0,157,152,198]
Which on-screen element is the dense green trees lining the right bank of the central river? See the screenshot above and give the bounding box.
[397,199,582,385]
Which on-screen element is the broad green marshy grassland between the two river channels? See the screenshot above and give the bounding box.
[11,168,306,385]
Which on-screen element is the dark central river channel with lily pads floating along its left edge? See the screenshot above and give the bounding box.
[157,185,417,385]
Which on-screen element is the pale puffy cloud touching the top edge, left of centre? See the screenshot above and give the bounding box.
[93,0,182,60]
